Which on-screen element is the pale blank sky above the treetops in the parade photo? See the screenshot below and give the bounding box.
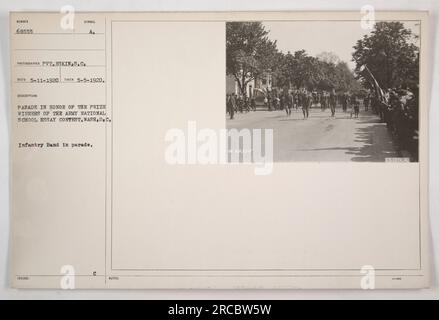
[263,21,419,69]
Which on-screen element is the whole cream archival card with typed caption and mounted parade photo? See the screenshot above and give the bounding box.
[10,11,431,289]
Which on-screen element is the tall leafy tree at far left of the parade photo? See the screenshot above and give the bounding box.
[226,22,278,95]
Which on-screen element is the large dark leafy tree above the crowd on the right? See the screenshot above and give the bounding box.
[352,22,419,89]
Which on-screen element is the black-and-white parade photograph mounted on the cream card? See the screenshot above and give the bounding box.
[226,21,420,162]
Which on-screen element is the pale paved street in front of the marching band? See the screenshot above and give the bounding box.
[227,108,400,162]
